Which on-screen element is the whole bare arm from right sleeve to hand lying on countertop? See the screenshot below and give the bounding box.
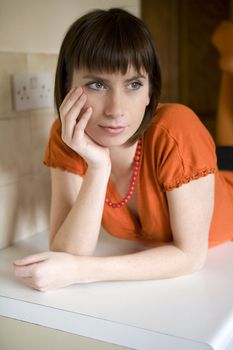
[15,174,214,291]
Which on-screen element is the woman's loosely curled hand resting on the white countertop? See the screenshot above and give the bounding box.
[14,252,86,292]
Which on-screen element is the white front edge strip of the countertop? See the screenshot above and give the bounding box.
[0,296,213,350]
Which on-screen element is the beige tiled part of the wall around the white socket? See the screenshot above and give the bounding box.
[0,52,57,248]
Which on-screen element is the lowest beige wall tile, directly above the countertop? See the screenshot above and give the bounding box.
[0,171,51,249]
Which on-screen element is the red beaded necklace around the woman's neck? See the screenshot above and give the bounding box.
[105,139,142,209]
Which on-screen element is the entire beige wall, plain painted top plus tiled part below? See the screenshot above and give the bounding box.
[0,0,140,248]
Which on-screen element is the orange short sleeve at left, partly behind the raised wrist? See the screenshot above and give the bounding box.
[43,119,87,176]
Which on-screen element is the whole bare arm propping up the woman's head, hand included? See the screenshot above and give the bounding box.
[50,88,111,255]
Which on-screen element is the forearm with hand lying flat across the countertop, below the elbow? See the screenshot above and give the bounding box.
[14,244,205,291]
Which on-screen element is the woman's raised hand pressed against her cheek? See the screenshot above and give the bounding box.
[59,87,110,167]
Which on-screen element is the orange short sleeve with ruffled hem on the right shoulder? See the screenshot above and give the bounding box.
[155,105,217,191]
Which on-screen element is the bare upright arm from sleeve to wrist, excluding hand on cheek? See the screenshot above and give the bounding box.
[50,168,109,255]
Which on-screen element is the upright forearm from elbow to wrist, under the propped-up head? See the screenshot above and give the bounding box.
[50,167,110,255]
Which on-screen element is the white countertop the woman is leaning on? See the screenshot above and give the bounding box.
[0,233,233,350]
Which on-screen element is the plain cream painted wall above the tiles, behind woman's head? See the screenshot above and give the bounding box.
[0,0,140,53]
